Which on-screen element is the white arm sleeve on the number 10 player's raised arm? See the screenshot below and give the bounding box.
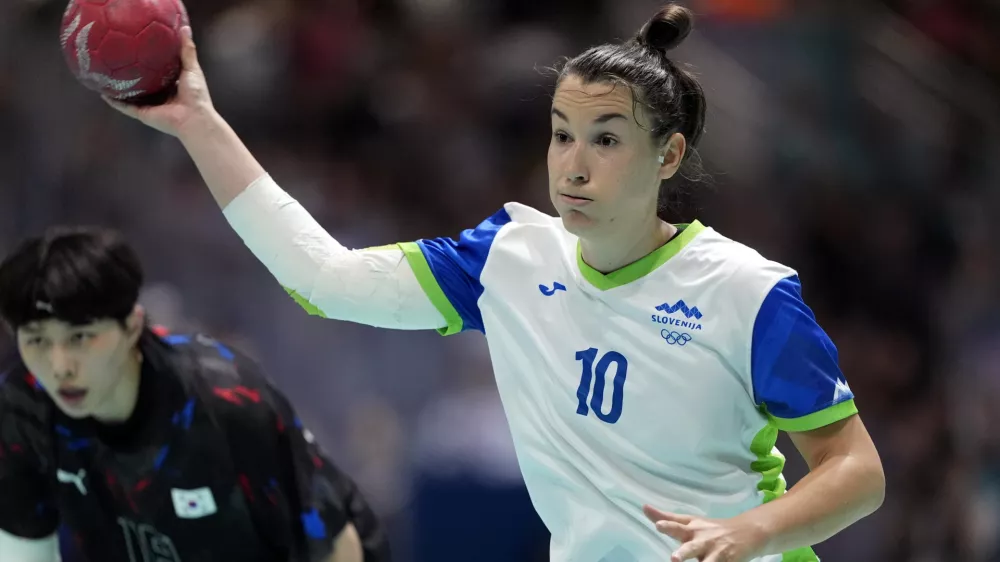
[225,175,447,328]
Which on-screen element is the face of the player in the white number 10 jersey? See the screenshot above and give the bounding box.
[548,74,684,237]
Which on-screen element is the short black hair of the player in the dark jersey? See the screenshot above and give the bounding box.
[0,227,143,330]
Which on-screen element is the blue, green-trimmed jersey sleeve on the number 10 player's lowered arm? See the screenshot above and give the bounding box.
[750,276,857,431]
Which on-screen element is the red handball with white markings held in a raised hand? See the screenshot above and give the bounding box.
[59,0,188,102]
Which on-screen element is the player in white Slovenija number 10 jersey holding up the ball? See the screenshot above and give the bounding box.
[105,5,885,562]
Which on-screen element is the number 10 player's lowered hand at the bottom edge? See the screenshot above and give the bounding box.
[642,505,767,562]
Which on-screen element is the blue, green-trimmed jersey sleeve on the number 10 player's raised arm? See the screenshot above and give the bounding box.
[401,209,510,334]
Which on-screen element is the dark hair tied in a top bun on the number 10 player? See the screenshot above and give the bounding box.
[559,4,707,218]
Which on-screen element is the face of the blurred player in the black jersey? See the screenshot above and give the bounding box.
[17,313,142,418]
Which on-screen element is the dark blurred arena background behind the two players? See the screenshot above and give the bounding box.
[0,0,1000,562]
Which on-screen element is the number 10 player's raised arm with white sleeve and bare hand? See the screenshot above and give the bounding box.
[105,28,448,329]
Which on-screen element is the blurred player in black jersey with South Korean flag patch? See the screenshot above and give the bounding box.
[0,229,387,562]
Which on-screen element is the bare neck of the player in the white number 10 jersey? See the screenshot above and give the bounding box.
[580,214,677,273]
